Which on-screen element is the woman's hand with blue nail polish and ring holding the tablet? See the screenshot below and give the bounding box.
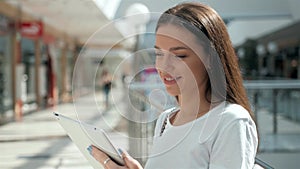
[88,145,143,169]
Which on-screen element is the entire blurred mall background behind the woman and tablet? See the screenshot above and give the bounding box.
[0,0,300,169]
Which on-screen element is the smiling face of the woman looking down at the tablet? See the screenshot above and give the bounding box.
[155,24,208,96]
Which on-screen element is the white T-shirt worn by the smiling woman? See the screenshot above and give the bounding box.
[145,102,258,169]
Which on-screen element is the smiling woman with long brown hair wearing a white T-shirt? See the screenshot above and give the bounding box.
[86,3,258,169]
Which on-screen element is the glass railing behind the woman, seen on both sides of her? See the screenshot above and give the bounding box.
[128,80,300,164]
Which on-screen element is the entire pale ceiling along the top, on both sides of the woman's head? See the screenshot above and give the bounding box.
[5,0,300,46]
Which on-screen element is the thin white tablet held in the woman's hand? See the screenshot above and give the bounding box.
[53,112,124,166]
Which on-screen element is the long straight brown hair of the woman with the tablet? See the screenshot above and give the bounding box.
[156,2,254,119]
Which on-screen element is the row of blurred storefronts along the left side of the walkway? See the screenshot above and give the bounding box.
[0,2,76,122]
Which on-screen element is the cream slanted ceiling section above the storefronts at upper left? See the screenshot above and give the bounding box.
[6,0,122,46]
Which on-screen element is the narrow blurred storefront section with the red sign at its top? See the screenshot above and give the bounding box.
[16,21,43,111]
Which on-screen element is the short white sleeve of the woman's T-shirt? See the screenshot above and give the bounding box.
[209,119,258,169]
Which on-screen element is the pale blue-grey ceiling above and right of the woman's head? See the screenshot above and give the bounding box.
[115,0,300,45]
